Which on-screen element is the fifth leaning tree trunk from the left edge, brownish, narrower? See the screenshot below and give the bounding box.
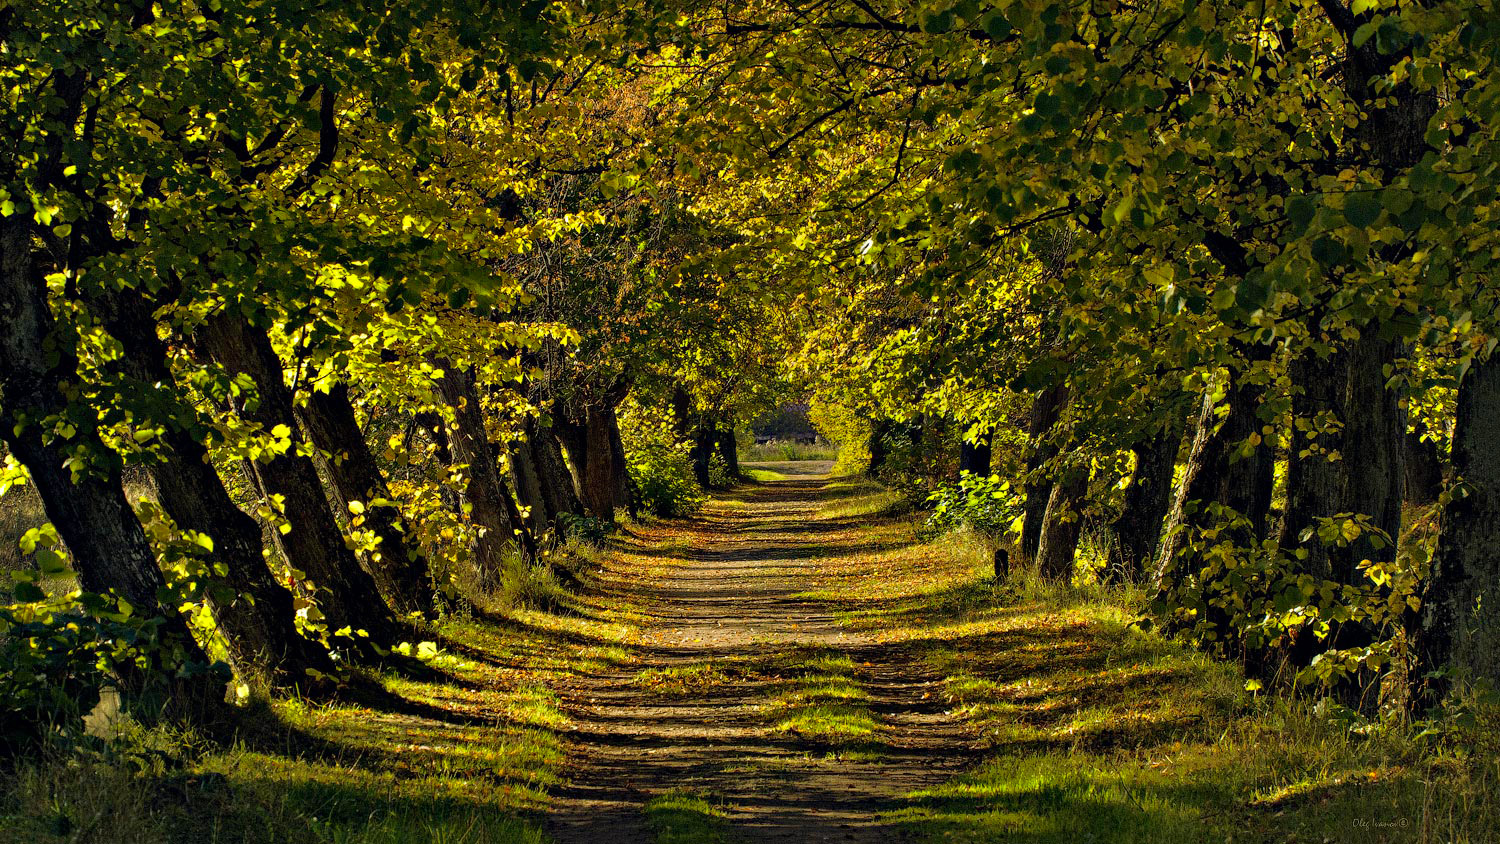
[437,358,537,586]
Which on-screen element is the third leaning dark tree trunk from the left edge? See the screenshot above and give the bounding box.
[200,312,399,655]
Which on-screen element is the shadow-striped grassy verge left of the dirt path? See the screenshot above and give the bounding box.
[0,542,635,844]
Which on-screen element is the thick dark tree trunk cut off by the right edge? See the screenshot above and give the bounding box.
[1410,354,1500,709]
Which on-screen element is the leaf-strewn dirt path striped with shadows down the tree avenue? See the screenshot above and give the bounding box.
[549,463,971,844]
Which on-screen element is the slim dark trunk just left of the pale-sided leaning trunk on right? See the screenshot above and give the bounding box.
[1106,420,1182,583]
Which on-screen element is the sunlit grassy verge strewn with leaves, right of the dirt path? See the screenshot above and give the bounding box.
[807,481,1500,844]
